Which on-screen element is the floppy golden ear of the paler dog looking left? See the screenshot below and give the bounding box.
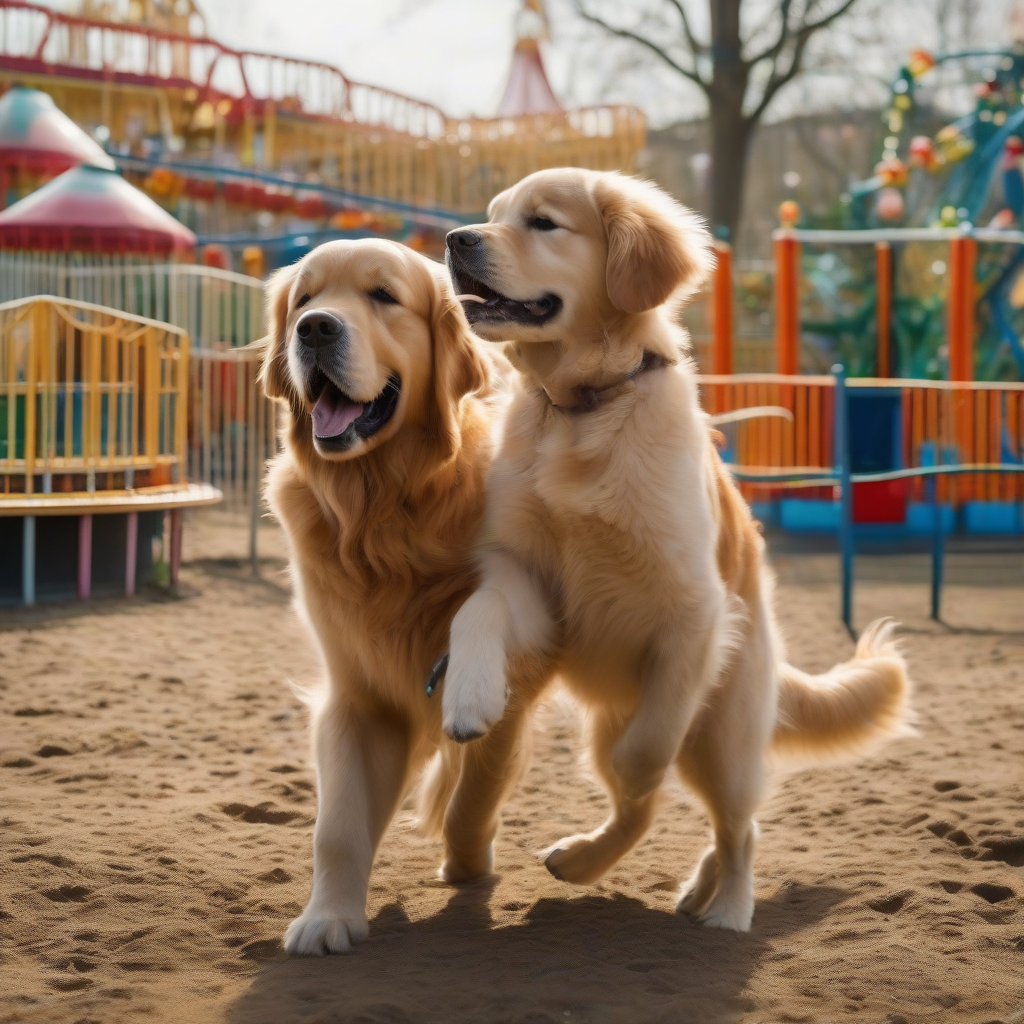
[594,174,715,313]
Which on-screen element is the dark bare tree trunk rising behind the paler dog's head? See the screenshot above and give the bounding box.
[708,0,753,247]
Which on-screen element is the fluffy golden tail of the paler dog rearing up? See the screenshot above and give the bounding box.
[772,618,912,757]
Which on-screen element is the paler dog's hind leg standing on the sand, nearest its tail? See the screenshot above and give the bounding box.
[677,602,775,932]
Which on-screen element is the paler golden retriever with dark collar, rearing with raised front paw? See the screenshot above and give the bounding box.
[442,169,909,931]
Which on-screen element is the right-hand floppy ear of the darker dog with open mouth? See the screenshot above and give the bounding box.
[430,270,490,460]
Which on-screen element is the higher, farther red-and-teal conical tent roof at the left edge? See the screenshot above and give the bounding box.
[0,86,114,210]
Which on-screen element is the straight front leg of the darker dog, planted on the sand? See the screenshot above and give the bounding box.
[285,701,413,955]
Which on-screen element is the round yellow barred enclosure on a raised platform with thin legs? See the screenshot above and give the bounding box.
[0,296,220,604]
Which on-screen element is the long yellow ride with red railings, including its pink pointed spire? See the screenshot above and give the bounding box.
[0,0,644,255]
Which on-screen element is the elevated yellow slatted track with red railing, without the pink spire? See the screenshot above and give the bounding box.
[0,0,644,214]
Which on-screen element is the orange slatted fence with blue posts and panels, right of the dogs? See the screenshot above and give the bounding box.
[700,366,1024,631]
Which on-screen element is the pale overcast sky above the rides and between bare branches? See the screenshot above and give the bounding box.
[190,0,1015,124]
